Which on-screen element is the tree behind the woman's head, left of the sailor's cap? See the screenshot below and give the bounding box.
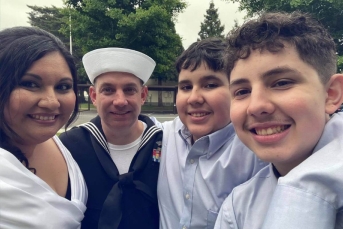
[28,5,88,83]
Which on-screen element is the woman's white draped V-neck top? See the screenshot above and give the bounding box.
[0,136,88,229]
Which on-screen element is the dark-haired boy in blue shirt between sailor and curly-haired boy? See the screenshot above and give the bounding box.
[155,38,266,229]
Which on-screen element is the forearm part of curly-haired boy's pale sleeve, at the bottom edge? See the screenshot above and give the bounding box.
[262,185,342,229]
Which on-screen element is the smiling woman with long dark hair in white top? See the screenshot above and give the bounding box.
[0,27,87,229]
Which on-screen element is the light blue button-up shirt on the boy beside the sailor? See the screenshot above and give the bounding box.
[152,117,267,229]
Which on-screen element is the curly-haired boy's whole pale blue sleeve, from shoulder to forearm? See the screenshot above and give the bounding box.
[263,112,343,229]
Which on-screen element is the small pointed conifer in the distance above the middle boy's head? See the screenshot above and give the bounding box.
[198,0,224,41]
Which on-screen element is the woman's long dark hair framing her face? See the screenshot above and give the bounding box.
[0,27,79,168]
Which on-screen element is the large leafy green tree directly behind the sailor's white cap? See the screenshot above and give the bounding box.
[61,0,186,83]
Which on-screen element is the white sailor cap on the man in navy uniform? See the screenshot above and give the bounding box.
[82,48,156,84]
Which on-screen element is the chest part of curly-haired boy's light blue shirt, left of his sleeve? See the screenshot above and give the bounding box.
[214,164,278,229]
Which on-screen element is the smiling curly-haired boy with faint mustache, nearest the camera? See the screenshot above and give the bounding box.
[215,12,343,229]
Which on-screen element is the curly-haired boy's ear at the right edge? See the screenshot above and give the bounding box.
[325,74,343,114]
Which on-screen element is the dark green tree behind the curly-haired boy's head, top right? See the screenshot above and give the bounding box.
[225,0,343,71]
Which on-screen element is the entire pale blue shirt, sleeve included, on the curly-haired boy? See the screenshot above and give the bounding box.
[215,113,343,229]
